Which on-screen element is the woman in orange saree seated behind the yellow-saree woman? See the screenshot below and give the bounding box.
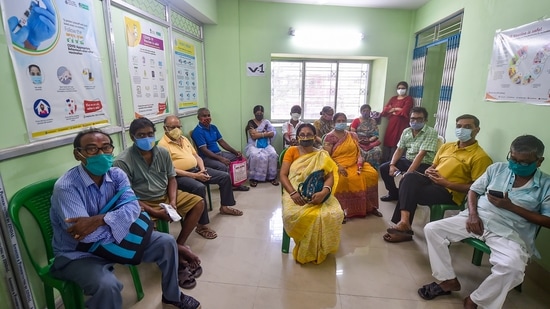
[323,113,382,218]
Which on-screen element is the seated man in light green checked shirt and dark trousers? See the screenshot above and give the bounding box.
[380,107,438,202]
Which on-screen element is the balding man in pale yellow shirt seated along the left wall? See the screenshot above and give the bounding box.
[158,115,243,239]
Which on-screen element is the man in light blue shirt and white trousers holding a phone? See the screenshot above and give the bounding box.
[418,135,550,309]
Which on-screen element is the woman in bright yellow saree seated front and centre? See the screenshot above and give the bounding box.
[280,123,344,264]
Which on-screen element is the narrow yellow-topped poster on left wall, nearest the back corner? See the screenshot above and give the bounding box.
[174,33,198,114]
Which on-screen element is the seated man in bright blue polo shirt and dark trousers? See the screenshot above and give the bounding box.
[191,107,250,191]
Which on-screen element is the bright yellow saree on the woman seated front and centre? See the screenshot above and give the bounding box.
[282,150,344,264]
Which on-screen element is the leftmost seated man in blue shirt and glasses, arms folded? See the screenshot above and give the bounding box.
[50,129,200,309]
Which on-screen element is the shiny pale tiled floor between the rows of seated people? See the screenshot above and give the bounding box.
[117,179,550,309]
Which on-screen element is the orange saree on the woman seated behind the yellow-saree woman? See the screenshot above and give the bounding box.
[325,132,378,218]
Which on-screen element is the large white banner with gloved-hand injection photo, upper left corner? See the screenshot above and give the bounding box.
[0,0,109,141]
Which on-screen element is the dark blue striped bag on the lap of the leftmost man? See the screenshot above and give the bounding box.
[76,187,153,265]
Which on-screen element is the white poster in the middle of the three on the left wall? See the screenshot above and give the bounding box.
[124,15,169,118]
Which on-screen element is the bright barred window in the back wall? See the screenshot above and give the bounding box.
[271,60,370,121]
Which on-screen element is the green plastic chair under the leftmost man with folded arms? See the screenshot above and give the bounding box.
[8,179,144,309]
